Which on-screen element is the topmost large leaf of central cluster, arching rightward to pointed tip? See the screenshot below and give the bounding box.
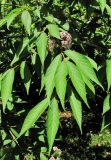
[65,50,103,88]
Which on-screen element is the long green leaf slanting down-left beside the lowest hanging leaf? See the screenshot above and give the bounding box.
[19,99,48,137]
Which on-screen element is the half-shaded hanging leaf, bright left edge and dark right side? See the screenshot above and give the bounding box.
[20,61,31,94]
